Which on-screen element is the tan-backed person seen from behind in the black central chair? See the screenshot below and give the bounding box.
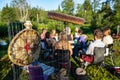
[55,32,73,55]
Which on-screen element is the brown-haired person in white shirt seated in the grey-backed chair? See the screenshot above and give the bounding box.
[82,29,105,66]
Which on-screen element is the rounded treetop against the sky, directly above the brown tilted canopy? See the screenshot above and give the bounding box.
[61,0,74,15]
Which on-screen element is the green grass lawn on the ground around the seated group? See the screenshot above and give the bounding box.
[0,36,120,80]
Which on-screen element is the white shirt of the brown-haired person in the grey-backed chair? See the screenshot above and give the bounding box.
[86,39,105,55]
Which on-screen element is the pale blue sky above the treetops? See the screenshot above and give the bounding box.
[0,0,105,10]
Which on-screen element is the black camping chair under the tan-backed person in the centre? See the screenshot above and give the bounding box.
[54,49,70,78]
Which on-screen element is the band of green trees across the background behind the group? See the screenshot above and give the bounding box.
[0,0,120,33]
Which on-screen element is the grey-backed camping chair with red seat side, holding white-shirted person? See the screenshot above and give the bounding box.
[82,47,106,76]
